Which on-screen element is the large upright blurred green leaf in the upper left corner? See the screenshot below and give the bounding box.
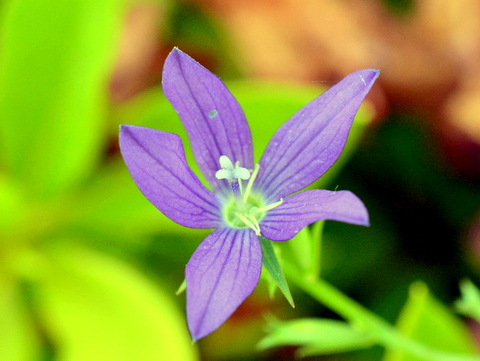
[0,0,124,197]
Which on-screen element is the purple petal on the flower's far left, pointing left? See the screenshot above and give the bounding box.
[120,125,222,228]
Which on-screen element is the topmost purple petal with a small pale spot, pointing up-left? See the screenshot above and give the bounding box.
[162,49,253,191]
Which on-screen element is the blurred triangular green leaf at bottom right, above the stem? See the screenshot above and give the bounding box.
[384,282,477,361]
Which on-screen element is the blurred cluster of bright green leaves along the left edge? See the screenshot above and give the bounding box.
[0,0,197,361]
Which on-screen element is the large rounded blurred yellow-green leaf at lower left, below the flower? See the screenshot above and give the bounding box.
[35,240,196,361]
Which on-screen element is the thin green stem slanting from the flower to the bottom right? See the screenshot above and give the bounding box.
[283,262,480,361]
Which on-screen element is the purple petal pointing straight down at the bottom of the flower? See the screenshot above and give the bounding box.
[185,228,262,340]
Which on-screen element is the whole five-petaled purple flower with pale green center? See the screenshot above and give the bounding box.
[120,49,378,340]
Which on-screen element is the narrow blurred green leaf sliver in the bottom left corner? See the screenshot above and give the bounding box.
[0,270,41,361]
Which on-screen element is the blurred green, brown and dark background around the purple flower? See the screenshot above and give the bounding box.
[0,0,480,361]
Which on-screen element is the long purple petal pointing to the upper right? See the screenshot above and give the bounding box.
[256,69,379,202]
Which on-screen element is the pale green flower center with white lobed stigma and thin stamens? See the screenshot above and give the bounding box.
[215,155,283,236]
